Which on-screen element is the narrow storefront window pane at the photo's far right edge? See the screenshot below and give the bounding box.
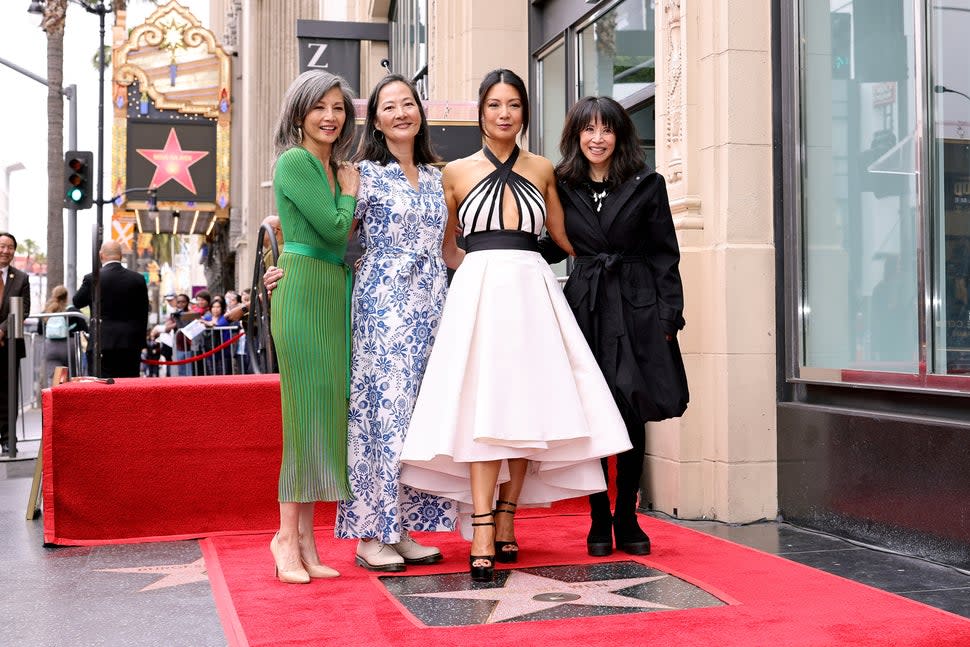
[928,0,970,375]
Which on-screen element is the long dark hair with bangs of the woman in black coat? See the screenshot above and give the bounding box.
[556,97,644,189]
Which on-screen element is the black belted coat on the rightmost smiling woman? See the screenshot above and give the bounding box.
[540,167,689,422]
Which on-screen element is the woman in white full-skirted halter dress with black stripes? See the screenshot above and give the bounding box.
[401,70,630,580]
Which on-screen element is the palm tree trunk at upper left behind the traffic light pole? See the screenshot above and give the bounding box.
[41,0,73,296]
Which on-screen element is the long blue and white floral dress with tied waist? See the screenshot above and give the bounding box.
[335,161,457,544]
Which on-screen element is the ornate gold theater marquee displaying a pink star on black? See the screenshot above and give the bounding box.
[111,0,231,234]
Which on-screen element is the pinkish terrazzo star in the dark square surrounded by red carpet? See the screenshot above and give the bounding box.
[402,571,673,624]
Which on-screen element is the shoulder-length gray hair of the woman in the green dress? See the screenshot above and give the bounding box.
[273,70,355,162]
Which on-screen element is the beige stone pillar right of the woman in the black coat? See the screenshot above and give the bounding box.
[644,0,777,522]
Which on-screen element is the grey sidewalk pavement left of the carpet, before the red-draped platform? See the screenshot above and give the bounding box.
[0,402,226,647]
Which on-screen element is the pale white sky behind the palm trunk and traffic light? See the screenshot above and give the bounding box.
[0,0,211,280]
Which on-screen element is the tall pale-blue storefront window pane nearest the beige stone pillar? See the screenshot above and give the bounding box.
[798,0,920,374]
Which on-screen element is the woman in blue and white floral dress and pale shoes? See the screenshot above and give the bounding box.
[264,74,464,572]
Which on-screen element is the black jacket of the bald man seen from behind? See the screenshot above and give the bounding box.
[74,263,148,350]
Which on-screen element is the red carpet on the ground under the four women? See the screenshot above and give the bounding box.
[202,513,970,647]
